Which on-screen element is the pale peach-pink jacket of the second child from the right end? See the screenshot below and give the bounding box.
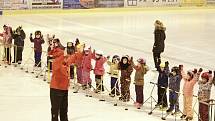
[182,71,200,96]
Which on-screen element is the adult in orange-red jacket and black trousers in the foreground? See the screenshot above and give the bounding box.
[48,39,74,121]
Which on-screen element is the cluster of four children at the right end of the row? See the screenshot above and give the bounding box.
[156,62,215,121]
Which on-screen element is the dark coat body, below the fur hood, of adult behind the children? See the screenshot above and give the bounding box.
[152,29,166,53]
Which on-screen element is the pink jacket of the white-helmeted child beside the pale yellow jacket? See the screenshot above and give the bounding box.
[93,53,107,75]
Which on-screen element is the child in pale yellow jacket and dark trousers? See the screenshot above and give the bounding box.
[107,55,120,97]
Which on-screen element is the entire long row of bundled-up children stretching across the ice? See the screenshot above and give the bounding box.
[0,25,215,121]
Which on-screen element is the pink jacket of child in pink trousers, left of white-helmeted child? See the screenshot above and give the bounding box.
[82,51,93,72]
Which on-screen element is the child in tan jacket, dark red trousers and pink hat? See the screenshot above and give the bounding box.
[132,58,148,109]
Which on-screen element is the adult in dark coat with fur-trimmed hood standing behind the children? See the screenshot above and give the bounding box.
[152,20,166,70]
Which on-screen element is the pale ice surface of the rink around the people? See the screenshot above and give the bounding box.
[0,9,215,121]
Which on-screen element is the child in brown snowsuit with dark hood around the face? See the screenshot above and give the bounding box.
[119,56,133,102]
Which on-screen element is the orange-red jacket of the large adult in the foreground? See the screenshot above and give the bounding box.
[48,48,74,90]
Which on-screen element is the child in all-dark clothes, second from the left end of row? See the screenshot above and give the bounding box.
[13,26,26,64]
